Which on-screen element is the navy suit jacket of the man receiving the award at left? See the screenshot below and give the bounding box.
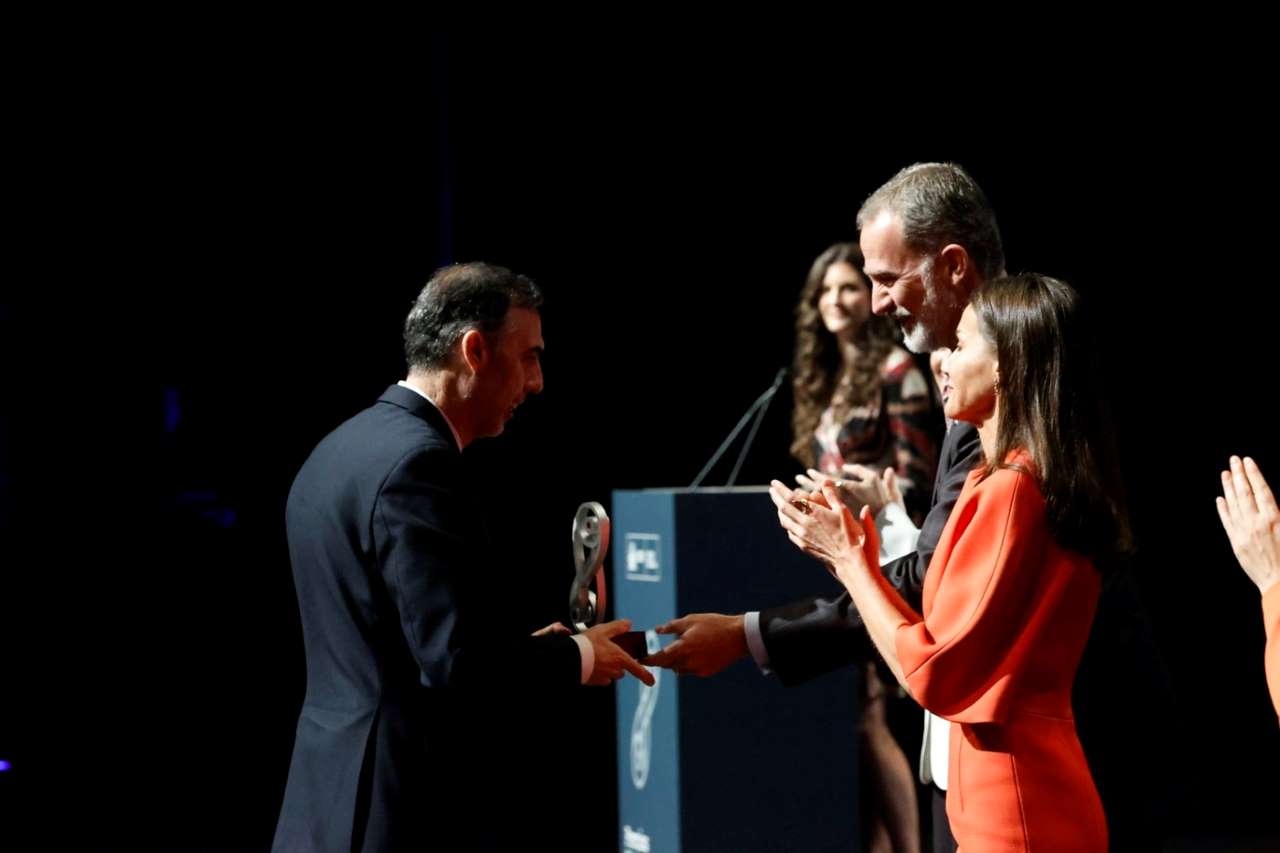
[280,386,581,852]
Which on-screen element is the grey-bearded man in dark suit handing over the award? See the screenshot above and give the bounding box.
[646,163,1170,850]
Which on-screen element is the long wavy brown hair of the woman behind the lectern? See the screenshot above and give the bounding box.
[791,243,897,467]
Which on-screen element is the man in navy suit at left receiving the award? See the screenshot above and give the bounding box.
[273,264,653,852]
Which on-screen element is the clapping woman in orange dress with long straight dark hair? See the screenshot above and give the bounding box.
[772,274,1129,853]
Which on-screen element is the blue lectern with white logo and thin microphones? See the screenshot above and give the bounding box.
[609,487,859,853]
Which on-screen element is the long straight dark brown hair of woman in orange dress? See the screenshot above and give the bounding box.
[970,273,1133,567]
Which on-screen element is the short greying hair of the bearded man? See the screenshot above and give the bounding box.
[858,163,1005,280]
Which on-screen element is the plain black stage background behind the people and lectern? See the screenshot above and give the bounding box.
[0,38,1280,850]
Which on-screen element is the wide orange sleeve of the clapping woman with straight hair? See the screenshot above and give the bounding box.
[895,469,1048,722]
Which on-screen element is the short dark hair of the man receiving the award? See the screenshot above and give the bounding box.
[404,257,543,371]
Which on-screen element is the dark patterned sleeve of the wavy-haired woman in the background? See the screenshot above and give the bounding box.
[881,348,942,524]
